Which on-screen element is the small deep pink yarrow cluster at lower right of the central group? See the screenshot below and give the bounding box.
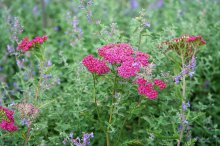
[135,78,166,99]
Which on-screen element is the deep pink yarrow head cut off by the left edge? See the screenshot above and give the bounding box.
[0,106,18,132]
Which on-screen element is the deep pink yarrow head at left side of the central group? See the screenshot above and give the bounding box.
[82,55,110,75]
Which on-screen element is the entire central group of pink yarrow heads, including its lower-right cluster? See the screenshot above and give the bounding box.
[82,43,166,99]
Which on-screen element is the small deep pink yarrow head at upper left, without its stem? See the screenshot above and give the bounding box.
[17,36,48,52]
